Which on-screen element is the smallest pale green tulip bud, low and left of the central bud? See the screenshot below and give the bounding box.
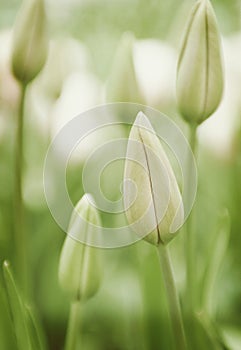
[59,194,101,301]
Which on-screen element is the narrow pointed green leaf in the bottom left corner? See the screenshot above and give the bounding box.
[3,261,32,350]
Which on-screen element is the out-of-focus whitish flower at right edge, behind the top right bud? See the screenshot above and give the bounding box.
[198,33,241,160]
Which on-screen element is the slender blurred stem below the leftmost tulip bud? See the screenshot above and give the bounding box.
[14,84,28,295]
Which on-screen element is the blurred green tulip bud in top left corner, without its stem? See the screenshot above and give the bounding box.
[12,0,48,84]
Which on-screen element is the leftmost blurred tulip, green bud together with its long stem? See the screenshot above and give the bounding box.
[12,0,47,294]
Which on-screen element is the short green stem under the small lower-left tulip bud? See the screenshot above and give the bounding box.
[65,301,81,350]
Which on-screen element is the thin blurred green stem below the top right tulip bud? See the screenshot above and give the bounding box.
[185,124,197,313]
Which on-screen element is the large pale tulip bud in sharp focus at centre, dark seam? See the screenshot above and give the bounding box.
[124,112,184,245]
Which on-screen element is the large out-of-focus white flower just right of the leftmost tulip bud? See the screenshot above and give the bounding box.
[23,38,102,138]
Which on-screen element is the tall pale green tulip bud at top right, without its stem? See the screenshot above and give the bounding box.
[177,0,223,124]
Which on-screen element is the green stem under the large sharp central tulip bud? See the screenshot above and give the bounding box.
[158,244,187,350]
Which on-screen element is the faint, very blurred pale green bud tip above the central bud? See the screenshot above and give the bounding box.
[106,32,142,103]
